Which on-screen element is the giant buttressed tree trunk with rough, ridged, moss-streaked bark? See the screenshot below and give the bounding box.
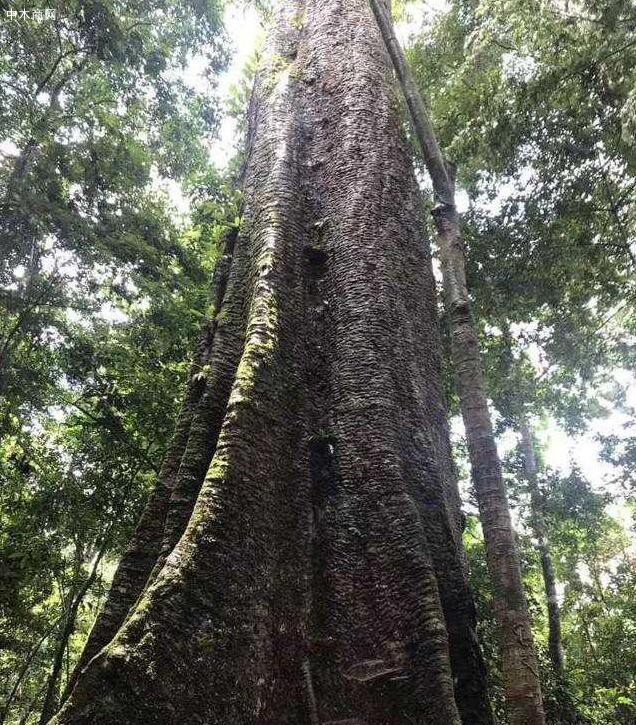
[54,0,492,725]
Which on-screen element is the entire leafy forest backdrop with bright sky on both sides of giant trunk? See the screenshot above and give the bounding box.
[0,0,636,725]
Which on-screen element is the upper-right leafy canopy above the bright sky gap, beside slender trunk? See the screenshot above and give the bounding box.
[410,0,636,425]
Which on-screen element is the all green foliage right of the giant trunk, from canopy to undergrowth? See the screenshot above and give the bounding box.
[408,0,636,725]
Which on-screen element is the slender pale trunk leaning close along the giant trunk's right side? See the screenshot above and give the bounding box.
[371,0,545,725]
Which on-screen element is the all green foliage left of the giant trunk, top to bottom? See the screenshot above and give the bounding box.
[0,0,229,723]
